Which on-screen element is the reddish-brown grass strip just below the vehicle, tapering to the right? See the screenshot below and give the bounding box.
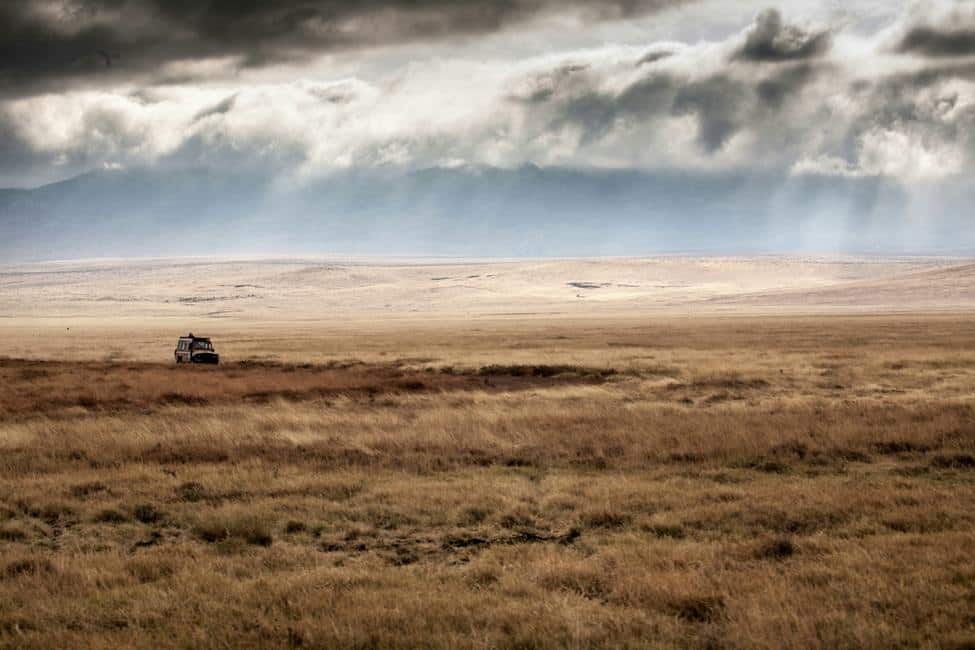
[0,357,615,416]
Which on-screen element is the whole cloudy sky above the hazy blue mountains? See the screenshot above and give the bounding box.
[0,0,975,200]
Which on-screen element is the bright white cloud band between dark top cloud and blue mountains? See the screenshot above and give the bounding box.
[0,4,975,190]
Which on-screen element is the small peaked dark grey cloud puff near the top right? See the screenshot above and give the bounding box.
[735,9,832,62]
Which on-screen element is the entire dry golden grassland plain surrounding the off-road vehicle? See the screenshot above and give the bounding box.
[0,257,975,648]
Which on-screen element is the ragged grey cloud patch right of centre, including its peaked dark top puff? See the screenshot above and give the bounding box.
[510,11,829,155]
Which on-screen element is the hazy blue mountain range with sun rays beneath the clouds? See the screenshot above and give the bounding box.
[0,166,972,261]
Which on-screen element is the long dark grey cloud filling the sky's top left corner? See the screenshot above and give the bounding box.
[0,0,693,96]
